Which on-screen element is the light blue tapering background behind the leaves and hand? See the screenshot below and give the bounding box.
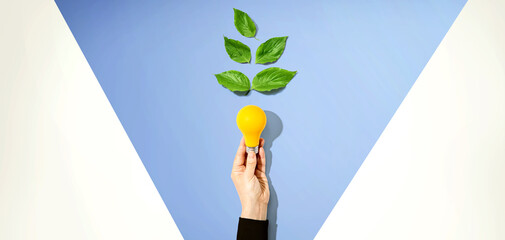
[56,0,466,239]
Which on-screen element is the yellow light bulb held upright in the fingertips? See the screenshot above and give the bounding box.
[237,105,267,153]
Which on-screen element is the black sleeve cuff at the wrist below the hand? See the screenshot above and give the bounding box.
[237,218,268,240]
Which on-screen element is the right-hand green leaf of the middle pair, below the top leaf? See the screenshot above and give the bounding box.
[255,37,288,64]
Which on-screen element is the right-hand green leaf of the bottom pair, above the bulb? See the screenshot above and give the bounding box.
[252,67,296,92]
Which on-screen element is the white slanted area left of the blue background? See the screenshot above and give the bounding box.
[0,0,182,240]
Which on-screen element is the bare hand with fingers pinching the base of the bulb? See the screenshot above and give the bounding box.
[231,138,270,220]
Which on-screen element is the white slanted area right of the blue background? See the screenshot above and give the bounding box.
[316,0,505,240]
